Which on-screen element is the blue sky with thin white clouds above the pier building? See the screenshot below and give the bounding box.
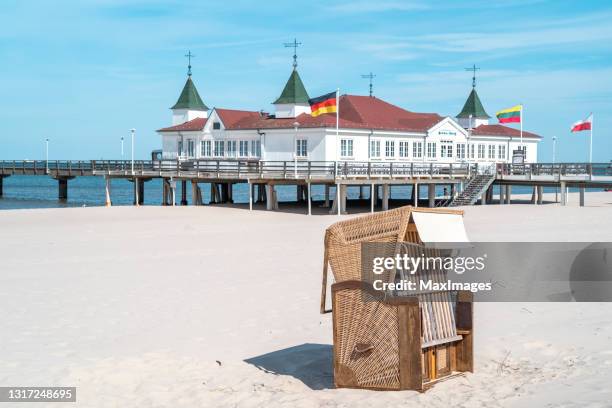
[0,0,612,162]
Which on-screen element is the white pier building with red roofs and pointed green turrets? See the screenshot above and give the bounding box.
[158,67,541,164]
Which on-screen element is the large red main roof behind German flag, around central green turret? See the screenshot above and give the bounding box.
[222,95,442,132]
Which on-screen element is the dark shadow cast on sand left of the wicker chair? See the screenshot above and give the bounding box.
[244,343,334,390]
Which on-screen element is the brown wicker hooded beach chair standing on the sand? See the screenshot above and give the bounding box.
[321,207,473,391]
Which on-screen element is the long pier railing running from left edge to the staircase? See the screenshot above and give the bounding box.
[0,159,474,179]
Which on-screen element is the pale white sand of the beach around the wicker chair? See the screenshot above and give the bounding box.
[0,193,612,407]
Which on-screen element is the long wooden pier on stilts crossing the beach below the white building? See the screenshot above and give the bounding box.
[0,159,612,214]
